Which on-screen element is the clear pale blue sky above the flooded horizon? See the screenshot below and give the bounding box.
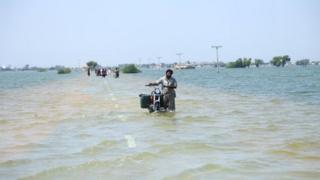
[0,0,320,67]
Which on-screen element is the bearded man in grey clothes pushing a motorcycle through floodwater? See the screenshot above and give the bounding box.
[147,69,177,112]
